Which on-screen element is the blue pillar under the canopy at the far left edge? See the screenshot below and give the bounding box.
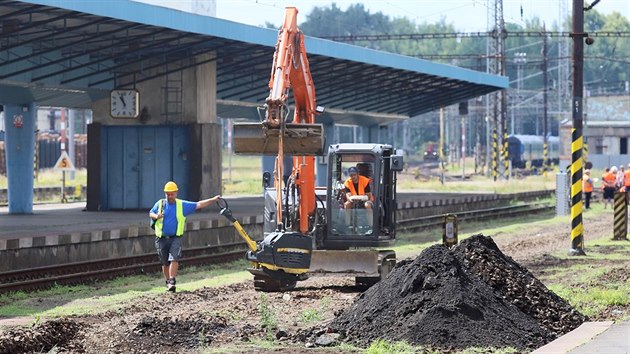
[4,103,37,214]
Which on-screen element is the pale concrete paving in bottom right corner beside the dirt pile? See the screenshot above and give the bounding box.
[532,321,630,354]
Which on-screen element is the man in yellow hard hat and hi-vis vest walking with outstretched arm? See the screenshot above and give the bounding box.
[149,181,221,292]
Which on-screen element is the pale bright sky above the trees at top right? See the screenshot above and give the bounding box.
[215,0,630,32]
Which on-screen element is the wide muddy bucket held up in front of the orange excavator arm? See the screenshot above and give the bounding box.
[232,123,324,156]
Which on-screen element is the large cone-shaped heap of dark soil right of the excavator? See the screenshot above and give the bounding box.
[331,235,585,349]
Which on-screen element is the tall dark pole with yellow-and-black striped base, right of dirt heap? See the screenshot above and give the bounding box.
[569,0,585,256]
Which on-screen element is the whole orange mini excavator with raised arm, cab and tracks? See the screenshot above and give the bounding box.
[227,7,403,291]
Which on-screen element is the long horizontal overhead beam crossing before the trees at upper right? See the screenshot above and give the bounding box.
[320,31,630,42]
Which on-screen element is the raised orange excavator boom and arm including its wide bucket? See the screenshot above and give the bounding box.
[234,7,324,234]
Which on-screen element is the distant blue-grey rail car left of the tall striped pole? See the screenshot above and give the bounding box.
[508,134,560,168]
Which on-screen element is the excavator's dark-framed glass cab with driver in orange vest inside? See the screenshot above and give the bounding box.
[318,144,402,249]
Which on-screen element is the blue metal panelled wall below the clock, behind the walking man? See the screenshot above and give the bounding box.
[101,126,189,210]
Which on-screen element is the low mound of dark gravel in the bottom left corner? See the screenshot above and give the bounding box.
[0,318,83,353]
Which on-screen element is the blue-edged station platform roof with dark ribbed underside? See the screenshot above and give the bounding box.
[0,0,508,125]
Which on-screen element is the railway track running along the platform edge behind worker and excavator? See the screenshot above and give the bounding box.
[0,204,554,293]
